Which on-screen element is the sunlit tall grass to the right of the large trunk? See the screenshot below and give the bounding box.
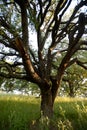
[55,98,87,130]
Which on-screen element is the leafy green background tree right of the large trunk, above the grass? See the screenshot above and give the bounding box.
[60,64,87,97]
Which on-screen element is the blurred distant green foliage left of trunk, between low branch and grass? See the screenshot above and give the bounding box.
[0,78,40,96]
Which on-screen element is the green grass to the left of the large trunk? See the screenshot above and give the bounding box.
[0,96,39,130]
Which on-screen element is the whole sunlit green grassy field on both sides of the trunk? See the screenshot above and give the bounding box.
[0,95,87,130]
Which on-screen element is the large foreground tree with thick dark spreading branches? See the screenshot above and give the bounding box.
[0,0,87,117]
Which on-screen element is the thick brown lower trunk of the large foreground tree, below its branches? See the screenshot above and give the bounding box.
[41,79,60,118]
